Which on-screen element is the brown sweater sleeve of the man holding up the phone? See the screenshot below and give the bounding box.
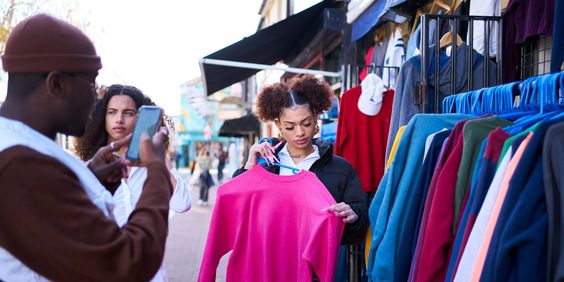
[0,146,172,281]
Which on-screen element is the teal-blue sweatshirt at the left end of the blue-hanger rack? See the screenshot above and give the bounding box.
[368,114,467,281]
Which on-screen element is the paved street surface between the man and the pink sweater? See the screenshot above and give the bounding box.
[164,170,228,282]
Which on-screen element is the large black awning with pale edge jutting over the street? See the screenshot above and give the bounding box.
[200,0,335,95]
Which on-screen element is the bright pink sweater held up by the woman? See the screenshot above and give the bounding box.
[198,166,344,282]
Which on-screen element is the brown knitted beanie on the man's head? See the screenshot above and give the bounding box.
[2,14,102,73]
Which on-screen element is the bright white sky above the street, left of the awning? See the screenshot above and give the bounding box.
[0,0,320,115]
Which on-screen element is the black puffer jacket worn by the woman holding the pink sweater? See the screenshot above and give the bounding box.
[233,138,369,245]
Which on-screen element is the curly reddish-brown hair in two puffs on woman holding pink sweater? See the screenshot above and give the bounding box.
[257,75,333,121]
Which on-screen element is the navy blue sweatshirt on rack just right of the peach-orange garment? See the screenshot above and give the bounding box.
[481,119,562,281]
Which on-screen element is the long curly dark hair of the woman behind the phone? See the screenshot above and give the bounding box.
[74,84,174,161]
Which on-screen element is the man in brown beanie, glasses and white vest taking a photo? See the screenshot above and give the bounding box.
[0,14,172,281]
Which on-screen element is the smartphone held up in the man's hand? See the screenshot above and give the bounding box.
[125,106,163,161]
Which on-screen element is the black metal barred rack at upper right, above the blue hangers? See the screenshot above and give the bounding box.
[420,14,503,113]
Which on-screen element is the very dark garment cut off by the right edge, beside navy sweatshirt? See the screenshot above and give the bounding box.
[542,122,564,281]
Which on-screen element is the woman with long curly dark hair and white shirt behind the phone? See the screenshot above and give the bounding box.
[75,84,192,281]
